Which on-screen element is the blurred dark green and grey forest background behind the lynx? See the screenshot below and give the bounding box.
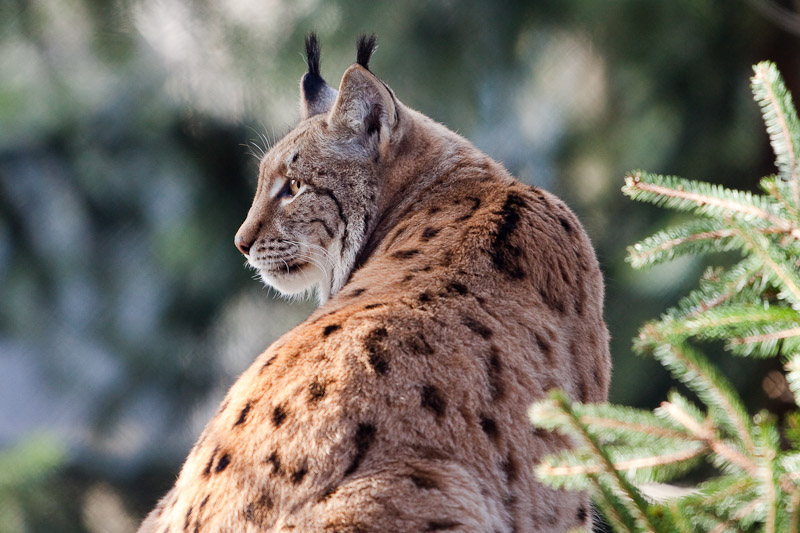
[0,0,800,532]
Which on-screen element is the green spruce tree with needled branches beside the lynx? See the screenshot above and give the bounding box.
[530,62,800,532]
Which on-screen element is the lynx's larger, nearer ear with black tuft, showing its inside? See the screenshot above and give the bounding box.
[328,34,397,152]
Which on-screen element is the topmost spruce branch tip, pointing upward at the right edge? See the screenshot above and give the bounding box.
[751,61,800,207]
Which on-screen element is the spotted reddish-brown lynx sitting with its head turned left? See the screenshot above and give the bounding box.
[140,34,610,533]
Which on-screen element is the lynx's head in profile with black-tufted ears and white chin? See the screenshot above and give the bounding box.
[234,33,402,303]
